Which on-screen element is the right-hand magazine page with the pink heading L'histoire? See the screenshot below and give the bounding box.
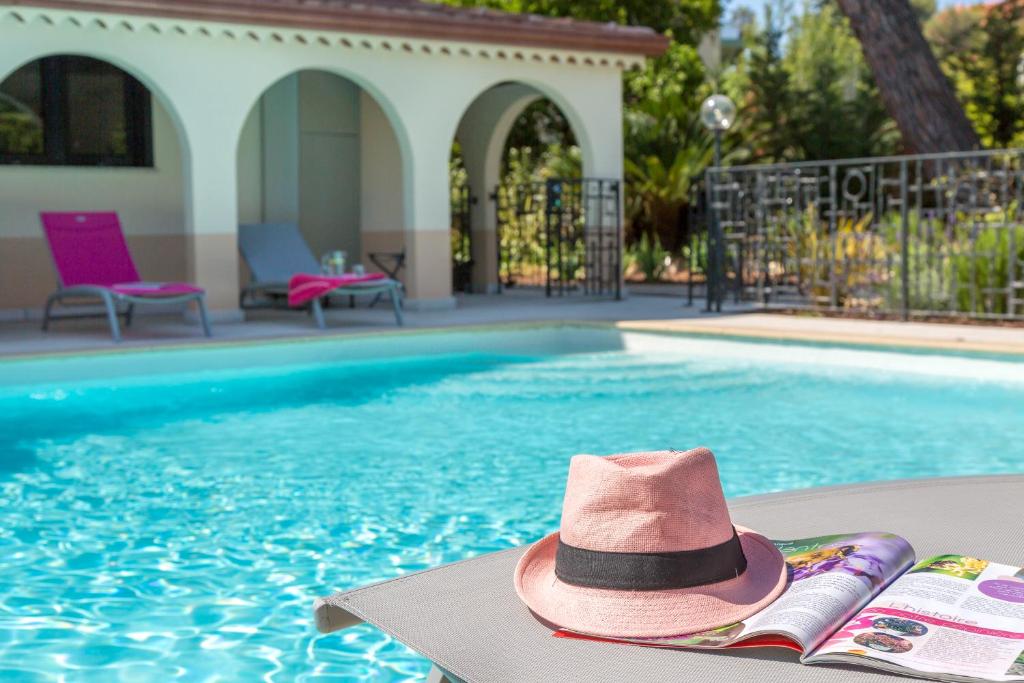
[807,555,1024,681]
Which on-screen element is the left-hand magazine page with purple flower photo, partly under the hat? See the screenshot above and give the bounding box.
[555,531,913,652]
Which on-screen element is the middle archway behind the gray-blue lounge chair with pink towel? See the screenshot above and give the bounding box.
[238,70,406,307]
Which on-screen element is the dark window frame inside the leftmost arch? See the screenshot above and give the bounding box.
[0,55,154,168]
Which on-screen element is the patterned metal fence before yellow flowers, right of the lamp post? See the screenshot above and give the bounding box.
[706,150,1024,318]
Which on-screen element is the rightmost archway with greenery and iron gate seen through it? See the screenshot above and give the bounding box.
[451,83,618,295]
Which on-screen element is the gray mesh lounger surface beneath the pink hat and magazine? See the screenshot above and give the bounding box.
[314,475,1024,683]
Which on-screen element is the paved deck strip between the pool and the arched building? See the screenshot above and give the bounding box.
[0,293,1024,357]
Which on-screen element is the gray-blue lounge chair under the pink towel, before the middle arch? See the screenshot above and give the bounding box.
[239,223,402,330]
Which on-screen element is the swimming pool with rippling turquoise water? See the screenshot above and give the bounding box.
[0,328,1024,681]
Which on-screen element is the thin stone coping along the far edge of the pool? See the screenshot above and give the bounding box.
[0,318,1024,367]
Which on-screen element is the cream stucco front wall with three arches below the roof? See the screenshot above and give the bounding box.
[0,1,639,310]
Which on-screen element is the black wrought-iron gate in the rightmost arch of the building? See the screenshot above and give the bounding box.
[493,178,623,299]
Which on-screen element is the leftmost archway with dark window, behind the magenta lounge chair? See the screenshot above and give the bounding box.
[0,54,188,309]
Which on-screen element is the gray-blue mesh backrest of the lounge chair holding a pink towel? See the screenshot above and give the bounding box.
[239,223,321,288]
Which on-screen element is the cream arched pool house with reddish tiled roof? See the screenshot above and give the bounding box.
[0,0,667,321]
